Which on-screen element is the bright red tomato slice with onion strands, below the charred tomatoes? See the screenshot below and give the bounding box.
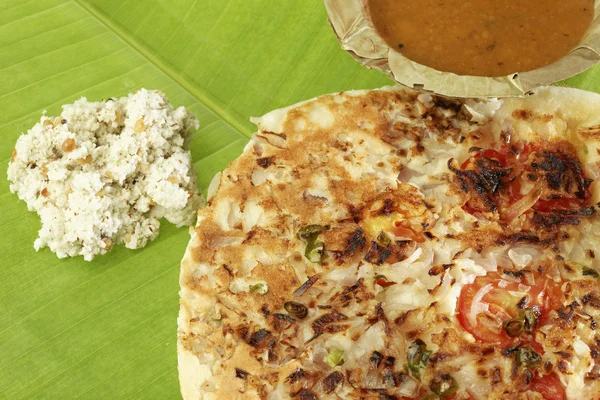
[456,272,562,345]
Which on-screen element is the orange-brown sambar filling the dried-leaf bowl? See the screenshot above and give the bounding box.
[368,0,594,76]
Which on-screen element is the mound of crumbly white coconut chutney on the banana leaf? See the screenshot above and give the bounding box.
[8,89,204,261]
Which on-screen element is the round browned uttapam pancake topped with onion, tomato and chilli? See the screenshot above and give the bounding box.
[178,88,600,400]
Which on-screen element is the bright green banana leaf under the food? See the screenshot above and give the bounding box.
[0,0,600,399]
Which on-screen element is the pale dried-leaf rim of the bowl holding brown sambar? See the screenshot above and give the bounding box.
[324,0,600,97]
